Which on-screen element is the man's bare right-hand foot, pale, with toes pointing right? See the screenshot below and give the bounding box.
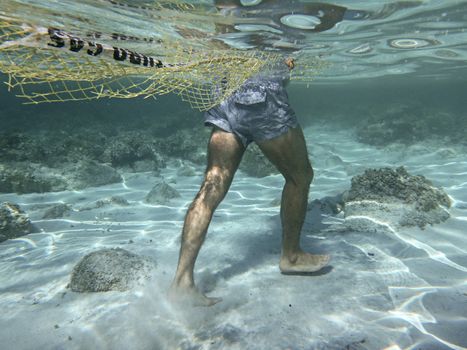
[279,252,331,273]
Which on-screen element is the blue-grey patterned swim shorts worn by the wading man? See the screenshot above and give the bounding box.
[205,77,298,147]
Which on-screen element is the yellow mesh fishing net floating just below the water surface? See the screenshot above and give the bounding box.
[0,2,326,110]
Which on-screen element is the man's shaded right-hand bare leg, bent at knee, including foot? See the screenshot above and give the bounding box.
[257,127,329,273]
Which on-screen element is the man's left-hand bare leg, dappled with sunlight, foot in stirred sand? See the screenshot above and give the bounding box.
[170,128,245,305]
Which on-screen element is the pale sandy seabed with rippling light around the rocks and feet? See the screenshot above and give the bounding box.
[0,127,467,350]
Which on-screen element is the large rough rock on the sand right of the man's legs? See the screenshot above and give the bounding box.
[344,167,451,231]
